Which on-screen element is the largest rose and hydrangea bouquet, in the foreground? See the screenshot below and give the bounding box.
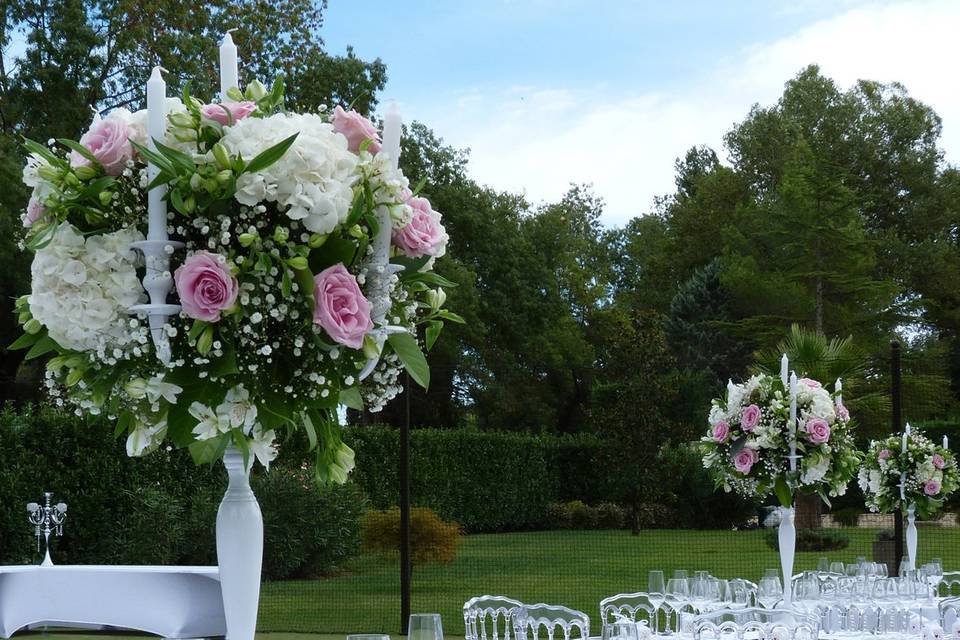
[13,77,460,482]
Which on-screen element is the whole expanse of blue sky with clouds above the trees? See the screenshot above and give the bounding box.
[321,0,960,226]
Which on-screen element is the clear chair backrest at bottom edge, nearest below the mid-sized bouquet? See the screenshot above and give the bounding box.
[693,608,820,640]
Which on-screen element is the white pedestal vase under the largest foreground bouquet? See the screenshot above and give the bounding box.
[217,446,263,640]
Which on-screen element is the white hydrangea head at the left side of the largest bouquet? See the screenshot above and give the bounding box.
[30,222,146,351]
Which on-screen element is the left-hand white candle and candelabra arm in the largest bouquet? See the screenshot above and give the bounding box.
[130,67,183,364]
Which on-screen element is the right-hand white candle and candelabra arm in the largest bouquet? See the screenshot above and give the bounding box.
[359,103,406,380]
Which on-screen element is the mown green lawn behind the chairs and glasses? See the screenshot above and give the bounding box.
[259,527,960,635]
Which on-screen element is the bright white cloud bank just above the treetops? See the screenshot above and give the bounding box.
[394,0,960,224]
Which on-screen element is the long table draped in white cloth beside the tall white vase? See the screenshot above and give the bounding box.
[0,565,226,638]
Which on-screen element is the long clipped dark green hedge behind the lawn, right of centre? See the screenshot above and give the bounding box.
[345,427,755,532]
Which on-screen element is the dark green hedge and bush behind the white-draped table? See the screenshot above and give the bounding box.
[0,410,365,579]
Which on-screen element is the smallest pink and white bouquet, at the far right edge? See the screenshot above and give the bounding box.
[857,431,960,518]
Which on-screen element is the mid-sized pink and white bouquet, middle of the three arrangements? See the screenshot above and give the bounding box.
[701,375,859,506]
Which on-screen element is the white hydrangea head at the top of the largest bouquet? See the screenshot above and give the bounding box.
[221,113,358,233]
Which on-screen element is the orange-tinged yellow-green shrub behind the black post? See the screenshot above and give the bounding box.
[362,507,462,565]
